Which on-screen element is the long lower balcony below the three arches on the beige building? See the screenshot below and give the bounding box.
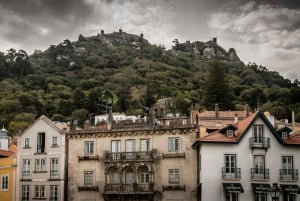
[104,183,153,194]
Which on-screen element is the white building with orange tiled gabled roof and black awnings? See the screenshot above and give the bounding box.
[193,112,300,201]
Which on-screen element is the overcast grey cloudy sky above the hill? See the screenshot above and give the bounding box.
[0,0,300,80]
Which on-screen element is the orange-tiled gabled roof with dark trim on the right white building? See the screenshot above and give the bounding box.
[197,111,284,144]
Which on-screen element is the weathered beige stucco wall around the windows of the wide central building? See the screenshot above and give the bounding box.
[68,130,196,201]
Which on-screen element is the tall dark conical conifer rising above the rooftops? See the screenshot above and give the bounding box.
[203,62,234,110]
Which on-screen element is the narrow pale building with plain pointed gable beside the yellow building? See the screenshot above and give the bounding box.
[16,116,66,201]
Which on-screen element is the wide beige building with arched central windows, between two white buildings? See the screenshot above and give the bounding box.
[67,119,197,201]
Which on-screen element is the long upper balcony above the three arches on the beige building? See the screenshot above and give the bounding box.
[105,151,153,162]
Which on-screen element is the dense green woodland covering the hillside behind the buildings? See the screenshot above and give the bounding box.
[0,32,300,135]
